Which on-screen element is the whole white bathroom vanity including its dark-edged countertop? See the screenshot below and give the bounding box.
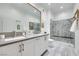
[0,34,48,56]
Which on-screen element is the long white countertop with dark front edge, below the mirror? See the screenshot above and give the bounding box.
[0,34,49,47]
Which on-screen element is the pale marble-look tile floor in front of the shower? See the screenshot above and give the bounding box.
[44,41,78,56]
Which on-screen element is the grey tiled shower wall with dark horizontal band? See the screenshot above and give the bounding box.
[50,19,75,44]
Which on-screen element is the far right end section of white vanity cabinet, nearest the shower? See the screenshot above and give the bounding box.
[35,36,48,56]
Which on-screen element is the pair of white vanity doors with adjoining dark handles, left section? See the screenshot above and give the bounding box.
[0,39,34,56]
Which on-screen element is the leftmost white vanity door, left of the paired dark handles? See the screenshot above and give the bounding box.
[0,43,21,56]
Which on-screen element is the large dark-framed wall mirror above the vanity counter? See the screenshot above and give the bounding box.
[0,3,41,34]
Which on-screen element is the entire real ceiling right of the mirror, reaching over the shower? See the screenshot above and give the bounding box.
[36,3,75,16]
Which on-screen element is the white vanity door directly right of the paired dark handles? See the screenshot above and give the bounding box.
[22,39,35,56]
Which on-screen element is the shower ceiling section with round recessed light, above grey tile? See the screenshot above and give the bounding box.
[50,3,75,16]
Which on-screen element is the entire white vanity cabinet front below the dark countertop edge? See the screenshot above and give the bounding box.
[0,35,48,56]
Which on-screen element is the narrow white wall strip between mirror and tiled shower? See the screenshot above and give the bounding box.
[41,11,51,38]
